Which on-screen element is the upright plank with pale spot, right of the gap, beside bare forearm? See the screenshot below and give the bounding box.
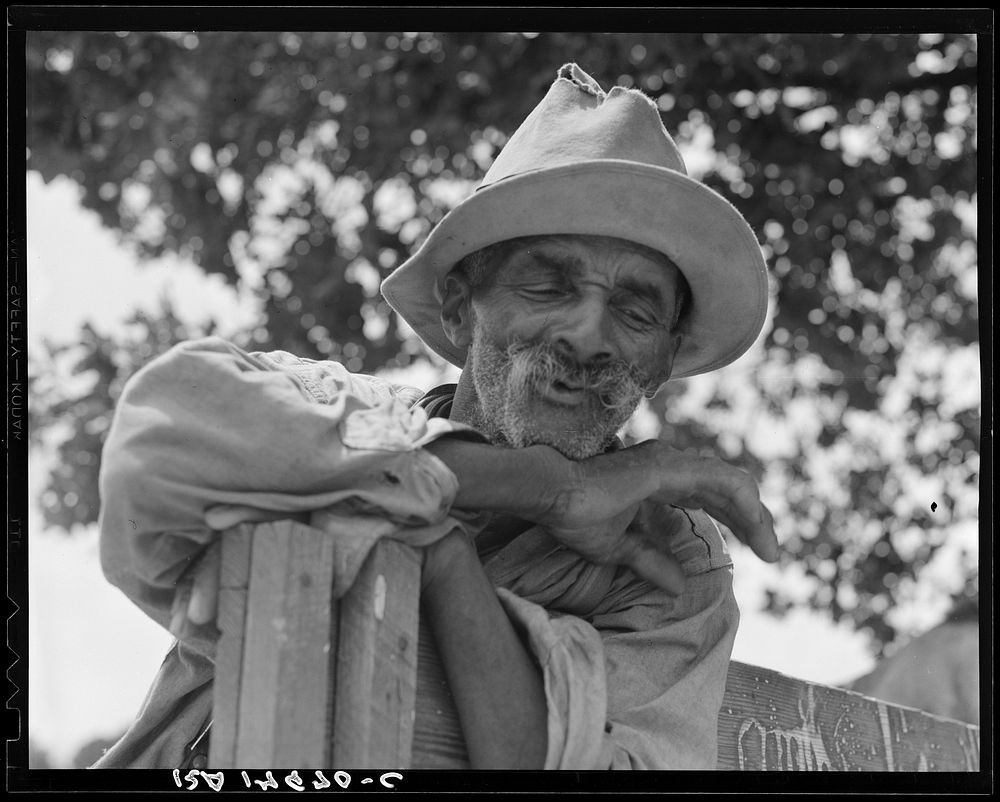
[333,540,420,769]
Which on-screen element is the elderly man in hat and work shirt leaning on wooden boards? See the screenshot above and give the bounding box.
[98,65,777,769]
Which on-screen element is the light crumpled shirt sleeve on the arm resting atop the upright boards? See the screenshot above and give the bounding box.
[100,338,478,626]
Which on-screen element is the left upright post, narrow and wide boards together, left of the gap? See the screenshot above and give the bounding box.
[209,521,336,768]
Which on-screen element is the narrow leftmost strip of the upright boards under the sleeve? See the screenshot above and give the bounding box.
[209,525,253,769]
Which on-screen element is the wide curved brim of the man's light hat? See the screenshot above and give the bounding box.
[382,159,768,378]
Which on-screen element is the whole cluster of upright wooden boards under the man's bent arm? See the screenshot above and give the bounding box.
[209,521,420,769]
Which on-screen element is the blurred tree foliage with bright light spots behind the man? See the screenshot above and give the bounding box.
[27,32,980,656]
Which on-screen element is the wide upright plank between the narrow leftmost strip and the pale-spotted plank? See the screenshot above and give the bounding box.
[236,521,334,768]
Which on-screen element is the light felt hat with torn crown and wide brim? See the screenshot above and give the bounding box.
[382,64,767,378]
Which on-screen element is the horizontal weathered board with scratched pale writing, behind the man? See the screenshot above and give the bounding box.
[718,662,979,772]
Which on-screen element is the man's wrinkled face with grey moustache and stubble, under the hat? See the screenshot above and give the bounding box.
[458,236,679,459]
